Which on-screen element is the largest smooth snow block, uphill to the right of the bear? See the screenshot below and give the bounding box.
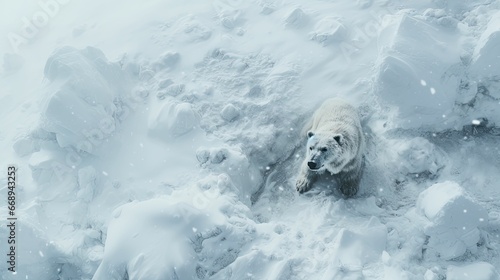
[375,14,460,128]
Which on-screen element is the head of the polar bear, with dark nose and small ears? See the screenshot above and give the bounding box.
[307,131,347,174]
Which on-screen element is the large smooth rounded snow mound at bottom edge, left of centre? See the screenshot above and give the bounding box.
[93,199,217,280]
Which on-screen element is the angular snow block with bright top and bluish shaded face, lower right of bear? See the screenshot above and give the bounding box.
[417,181,488,260]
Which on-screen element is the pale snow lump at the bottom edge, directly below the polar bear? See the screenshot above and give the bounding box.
[324,217,387,279]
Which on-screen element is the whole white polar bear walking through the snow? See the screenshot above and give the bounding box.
[296,98,365,197]
